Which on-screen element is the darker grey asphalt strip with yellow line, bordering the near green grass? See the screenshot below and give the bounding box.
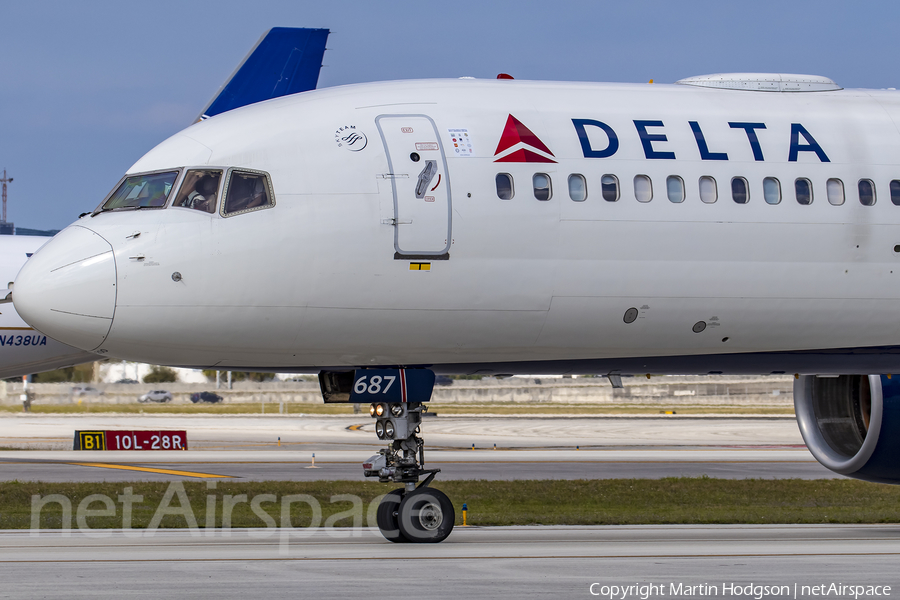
[0,448,839,482]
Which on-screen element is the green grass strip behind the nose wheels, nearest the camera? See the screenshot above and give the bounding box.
[0,477,900,529]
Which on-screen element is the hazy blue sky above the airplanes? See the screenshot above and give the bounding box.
[0,0,900,229]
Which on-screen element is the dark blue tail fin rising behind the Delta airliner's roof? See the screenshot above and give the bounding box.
[197,27,330,121]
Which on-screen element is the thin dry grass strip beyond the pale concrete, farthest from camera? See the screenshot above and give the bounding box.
[0,402,794,418]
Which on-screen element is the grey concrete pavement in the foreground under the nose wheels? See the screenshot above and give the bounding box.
[0,525,900,600]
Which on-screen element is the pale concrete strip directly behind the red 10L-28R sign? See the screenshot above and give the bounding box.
[0,413,803,450]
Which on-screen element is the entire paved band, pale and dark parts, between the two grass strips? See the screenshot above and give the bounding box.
[0,415,837,481]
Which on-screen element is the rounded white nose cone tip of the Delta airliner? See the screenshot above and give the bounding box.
[13,225,116,350]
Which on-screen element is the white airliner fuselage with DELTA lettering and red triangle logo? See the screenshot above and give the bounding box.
[14,80,900,372]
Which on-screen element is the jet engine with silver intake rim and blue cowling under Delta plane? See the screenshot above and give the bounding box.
[794,375,900,484]
